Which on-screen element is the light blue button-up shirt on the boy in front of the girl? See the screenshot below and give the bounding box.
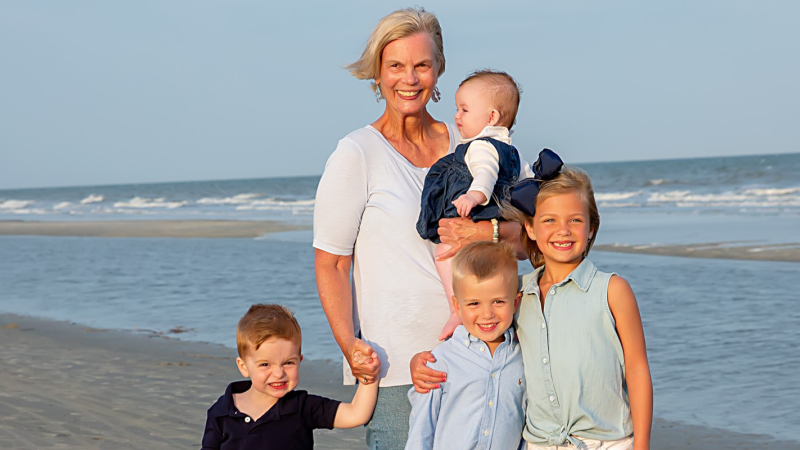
[406,325,526,450]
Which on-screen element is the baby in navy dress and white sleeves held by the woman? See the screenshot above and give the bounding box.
[417,70,533,340]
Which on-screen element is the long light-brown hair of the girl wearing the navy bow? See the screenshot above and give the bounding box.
[500,165,600,267]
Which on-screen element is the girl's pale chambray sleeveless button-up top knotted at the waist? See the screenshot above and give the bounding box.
[517,259,633,448]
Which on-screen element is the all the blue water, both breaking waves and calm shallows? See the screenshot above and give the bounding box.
[0,154,800,440]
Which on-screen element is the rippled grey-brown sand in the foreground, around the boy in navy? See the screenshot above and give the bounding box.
[0,314,800,450]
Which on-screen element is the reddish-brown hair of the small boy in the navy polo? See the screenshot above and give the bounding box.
[236,304,303,358]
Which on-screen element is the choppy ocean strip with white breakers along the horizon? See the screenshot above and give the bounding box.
[0,153,800,224]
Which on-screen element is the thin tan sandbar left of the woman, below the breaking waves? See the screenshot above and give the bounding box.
[0,220,307,238]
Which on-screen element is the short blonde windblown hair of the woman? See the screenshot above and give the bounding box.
[345,7,445,92]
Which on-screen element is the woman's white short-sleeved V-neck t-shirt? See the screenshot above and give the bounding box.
[314,124,460,386]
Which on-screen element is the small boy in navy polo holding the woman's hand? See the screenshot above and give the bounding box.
[202,304,378,450]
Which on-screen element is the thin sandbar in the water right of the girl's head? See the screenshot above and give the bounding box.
[592,242,800,262]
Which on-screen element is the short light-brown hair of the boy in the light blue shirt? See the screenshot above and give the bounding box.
[452,241,519,289]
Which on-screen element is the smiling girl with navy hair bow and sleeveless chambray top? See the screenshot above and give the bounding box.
[411,155,653,450]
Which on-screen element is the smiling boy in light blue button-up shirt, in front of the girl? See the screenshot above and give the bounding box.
[406,242,526,450]
